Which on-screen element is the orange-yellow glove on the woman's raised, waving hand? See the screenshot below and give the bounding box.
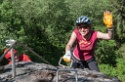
[103,11,113,29]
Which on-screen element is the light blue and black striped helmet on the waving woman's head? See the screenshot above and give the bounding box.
[76,16,91,26]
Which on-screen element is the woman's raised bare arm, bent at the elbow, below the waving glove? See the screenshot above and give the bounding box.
[97,29,113,40]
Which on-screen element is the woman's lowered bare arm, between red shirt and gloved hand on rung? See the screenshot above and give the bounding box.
[65,32,76,51]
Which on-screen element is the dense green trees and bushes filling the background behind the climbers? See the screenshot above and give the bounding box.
[0,0,125,82]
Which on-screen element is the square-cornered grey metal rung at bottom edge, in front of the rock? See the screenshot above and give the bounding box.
[56,68,78,82]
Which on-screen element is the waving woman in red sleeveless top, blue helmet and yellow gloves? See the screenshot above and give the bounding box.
[63,11,113,72]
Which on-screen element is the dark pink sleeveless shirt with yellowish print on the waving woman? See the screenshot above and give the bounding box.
[73,29,97,61]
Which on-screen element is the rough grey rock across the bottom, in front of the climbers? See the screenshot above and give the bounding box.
[0,62,120,82]
